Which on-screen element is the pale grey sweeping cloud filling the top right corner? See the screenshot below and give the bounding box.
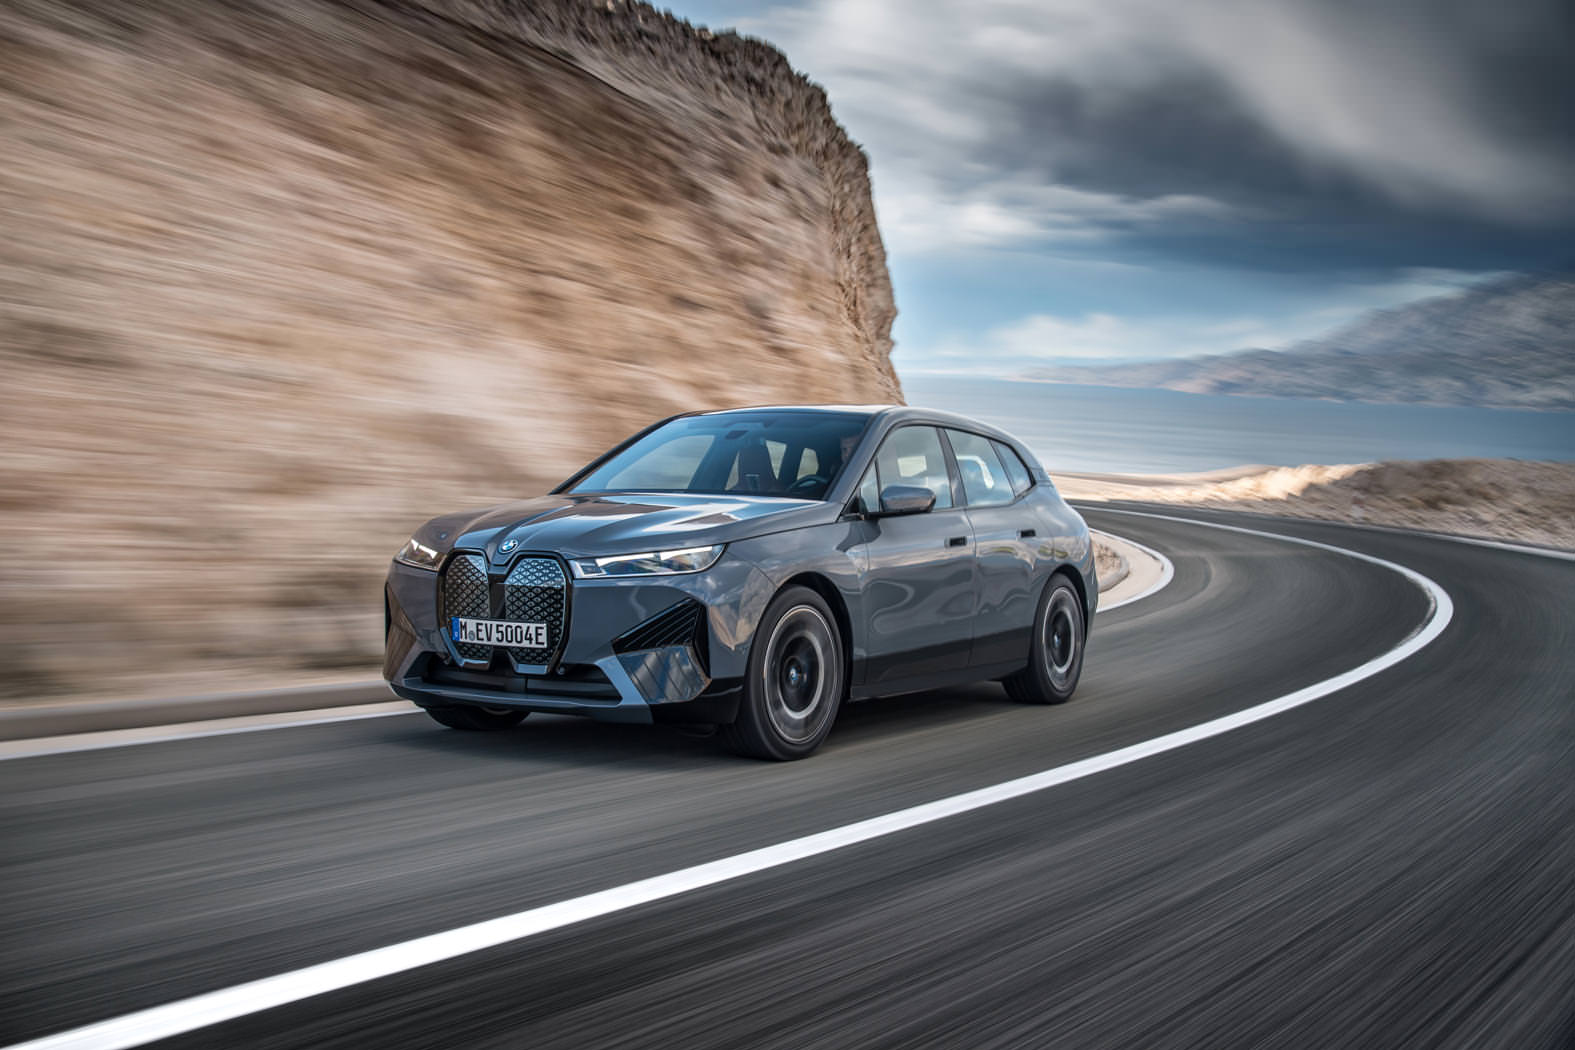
[1166,0,1575,220]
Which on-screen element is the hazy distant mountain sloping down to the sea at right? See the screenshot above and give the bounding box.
[1024,275,1575,409]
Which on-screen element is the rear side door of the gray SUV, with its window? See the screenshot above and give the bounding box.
[947,428,1043,667]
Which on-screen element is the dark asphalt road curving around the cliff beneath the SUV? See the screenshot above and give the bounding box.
[0,508,1575,1050]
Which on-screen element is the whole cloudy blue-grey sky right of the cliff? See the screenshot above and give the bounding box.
[658,0,1575,375]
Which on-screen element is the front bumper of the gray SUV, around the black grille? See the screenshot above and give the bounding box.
[383,553,770,723]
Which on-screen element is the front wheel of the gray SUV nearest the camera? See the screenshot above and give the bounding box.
[721,587,846,762]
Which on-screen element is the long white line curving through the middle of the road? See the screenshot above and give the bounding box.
[9,512,1454,1050]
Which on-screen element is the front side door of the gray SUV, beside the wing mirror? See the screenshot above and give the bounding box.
[860,425,978,685]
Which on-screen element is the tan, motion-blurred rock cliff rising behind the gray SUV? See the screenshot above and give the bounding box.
[0,0,901,697]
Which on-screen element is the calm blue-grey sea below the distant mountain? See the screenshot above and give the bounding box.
[902,375,1575,474]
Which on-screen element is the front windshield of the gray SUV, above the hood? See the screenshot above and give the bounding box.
[569,411,869,499]
